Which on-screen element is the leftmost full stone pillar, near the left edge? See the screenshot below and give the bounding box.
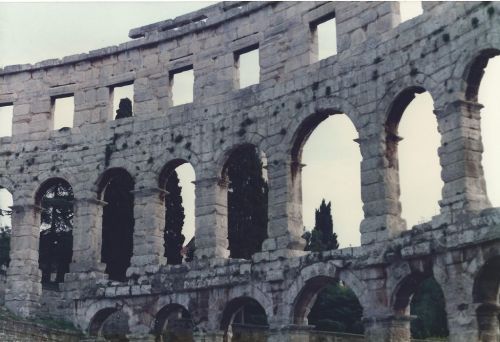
[5,204,42,317]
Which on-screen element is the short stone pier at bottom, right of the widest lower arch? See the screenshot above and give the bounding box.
[363,315,411,342]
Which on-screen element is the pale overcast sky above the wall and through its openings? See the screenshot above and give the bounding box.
[0,2,500,247]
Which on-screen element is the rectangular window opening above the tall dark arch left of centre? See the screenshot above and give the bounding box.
[234,45,260,89]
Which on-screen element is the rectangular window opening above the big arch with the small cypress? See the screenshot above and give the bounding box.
[310,13,337,61]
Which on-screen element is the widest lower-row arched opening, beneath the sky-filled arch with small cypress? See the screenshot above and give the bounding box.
[293,276,364,338]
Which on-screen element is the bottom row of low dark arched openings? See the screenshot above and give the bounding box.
[87,251,500,342]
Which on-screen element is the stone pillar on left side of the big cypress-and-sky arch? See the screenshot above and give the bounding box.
[262,160,305,256]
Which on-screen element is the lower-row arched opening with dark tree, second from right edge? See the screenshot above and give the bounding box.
[394,273,448,340]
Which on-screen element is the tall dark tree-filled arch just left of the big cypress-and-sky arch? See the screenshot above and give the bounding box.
[222,144,268,259]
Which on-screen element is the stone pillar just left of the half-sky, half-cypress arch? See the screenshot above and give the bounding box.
[127,187,166,277]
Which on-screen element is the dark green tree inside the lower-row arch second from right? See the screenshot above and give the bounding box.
[410,277,448,339]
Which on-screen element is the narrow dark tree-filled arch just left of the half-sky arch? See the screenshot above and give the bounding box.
[99,168,135,281]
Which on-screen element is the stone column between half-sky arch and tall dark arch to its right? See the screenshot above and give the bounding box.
[195,177,229,259]
